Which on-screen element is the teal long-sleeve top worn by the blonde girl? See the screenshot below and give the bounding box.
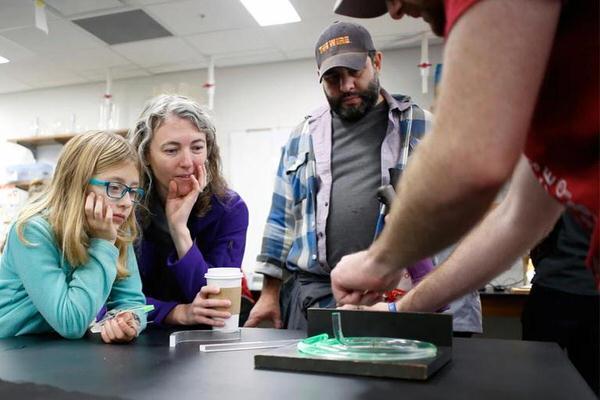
[0,216,146,339]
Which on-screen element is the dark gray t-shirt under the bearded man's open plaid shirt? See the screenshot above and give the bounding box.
[326,101,388,268]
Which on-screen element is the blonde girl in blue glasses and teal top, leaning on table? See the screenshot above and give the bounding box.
[0,132,146,343]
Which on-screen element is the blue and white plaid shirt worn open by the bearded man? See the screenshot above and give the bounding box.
[256,90,431,279]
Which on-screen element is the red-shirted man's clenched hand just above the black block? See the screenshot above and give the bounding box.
[331,250,403,305]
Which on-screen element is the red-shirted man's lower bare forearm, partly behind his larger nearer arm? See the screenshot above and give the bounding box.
[398,157,564,311]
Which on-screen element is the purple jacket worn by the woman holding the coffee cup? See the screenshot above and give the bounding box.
[135,191,248,324]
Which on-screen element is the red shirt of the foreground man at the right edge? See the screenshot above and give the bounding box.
[445,0,600,287]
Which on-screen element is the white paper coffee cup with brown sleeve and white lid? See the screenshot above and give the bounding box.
[204,267,243,332]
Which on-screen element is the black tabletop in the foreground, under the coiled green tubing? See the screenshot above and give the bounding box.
[0,328,595,400]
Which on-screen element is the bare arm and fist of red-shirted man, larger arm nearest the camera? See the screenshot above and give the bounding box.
[332,0,560,304]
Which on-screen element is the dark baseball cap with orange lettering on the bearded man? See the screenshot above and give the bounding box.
[315,21,375,80]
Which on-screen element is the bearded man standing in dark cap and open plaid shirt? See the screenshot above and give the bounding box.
[245,22,481,332]
